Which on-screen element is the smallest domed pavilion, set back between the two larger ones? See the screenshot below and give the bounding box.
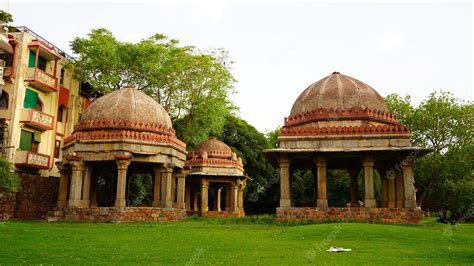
[186,138,247,217]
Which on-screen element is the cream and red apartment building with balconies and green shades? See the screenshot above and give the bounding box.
[0,27,90,177]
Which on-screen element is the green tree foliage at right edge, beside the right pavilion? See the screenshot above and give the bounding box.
[386,91,474,214]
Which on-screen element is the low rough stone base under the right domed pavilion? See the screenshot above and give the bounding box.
[276,207,423,224]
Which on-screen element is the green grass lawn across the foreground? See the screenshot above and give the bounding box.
[0,217,474,265]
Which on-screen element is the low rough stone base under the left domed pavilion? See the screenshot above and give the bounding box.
[48,207,186,223]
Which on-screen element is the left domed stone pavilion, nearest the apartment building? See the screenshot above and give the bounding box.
[54,88,186,221]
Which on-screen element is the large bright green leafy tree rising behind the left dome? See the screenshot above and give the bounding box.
[71,28,235,148]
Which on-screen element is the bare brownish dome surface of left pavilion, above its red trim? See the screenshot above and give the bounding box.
[81,88,172,128]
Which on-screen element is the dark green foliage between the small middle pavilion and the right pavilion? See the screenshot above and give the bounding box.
[218,115,280,213]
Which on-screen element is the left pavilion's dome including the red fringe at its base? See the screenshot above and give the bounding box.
[76,88,174,135]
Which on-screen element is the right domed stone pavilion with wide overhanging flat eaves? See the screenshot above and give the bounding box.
[266,72,427,223]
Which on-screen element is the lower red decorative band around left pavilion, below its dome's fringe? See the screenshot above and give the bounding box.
[64,130,186,150]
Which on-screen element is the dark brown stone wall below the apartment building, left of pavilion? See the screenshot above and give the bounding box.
[0,173,59,220]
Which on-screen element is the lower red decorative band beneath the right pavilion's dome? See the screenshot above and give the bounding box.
[281,125,410,136]
